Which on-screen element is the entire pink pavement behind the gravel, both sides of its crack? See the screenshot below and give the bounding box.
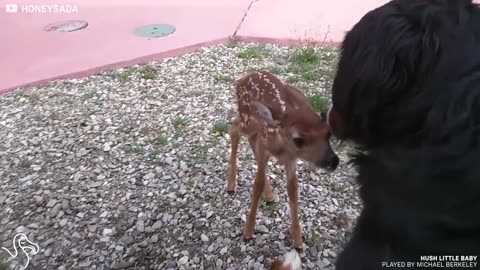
[0,0,462,93]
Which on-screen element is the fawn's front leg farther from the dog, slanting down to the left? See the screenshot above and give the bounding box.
[243,140,268,240]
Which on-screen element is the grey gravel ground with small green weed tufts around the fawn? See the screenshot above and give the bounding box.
[0,42,360,270]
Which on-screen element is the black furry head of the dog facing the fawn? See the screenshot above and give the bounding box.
[327,0,480,149]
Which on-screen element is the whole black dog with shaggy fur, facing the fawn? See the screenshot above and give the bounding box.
[328,0,480,270]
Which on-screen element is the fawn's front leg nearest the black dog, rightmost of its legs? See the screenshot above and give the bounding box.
[285,161,303,249]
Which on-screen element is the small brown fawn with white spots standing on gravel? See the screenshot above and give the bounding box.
[227,71,339,248]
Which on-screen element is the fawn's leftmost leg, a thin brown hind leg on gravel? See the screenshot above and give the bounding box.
[227,118,242,194]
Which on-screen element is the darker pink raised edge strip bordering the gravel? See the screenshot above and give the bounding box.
[0,36,340,95]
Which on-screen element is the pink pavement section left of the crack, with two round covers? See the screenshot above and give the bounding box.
[0,0,250,92]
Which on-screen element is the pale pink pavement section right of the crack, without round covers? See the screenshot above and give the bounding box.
[237,0,388,44]
